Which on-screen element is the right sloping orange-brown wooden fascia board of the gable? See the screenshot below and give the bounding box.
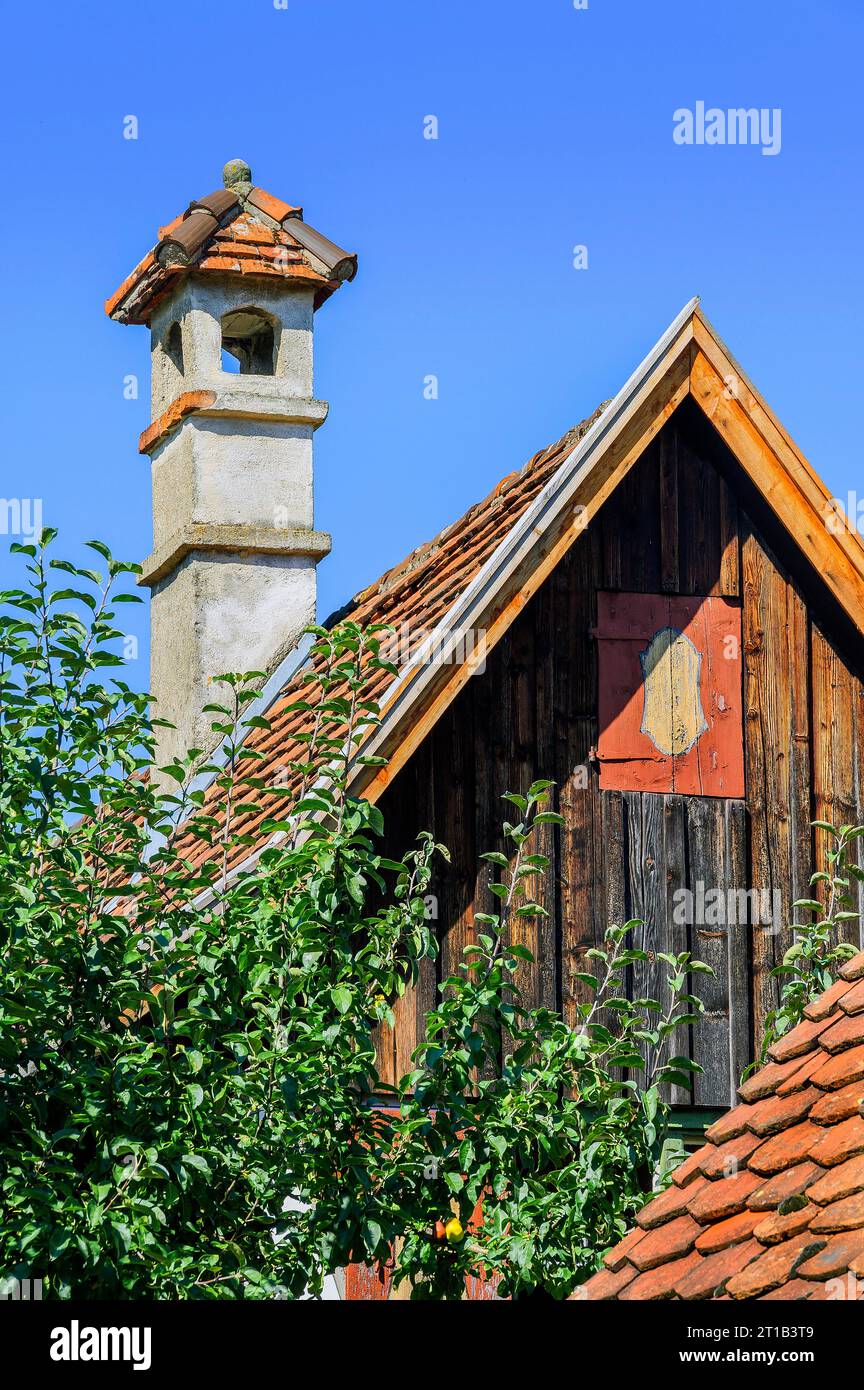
[690,344,864,632]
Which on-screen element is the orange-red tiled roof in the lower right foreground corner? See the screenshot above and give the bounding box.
[576,952,864,1300]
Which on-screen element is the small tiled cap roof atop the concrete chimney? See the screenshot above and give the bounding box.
[106,161,357,324]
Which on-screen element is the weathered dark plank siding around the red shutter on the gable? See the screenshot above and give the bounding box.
[381,404,864,1105]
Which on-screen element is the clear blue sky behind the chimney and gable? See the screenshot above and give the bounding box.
[0,0,864,685]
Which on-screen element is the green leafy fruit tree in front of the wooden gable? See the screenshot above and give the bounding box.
[0,532,700,1298]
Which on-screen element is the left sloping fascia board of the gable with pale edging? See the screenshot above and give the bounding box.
[351,306,693,801]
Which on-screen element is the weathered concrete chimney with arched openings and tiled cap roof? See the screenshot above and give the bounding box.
[106,160,357,765]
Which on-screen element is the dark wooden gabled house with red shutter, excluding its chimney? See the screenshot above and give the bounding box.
[343,303,864,1122]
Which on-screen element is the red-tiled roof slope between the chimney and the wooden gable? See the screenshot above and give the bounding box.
[176,406,604,863]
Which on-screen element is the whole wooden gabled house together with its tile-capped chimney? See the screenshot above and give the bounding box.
[107,179,864,1119]
